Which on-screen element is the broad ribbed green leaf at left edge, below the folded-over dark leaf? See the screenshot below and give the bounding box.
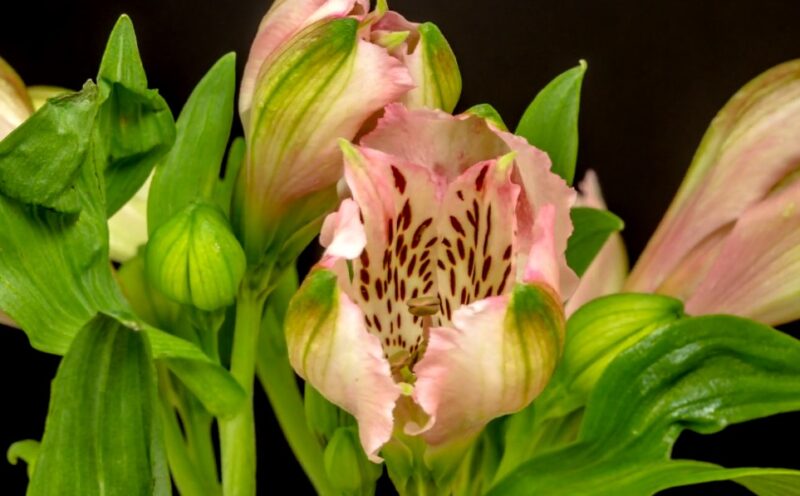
[0,112,125,354]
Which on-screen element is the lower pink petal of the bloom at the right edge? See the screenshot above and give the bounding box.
[686,180,800,325]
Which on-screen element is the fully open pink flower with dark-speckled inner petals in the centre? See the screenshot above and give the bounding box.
[286,104,575,460]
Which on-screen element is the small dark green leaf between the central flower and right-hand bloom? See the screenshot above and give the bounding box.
[566,207,625,276]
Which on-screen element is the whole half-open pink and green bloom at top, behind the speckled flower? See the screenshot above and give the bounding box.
[233,0,461,263]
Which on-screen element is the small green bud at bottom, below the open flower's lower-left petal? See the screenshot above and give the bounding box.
[324,427,383,494]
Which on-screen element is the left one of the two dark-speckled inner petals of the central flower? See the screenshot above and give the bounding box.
[341,144,444,365]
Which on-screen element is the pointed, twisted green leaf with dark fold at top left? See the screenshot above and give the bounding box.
[96,15,175,217]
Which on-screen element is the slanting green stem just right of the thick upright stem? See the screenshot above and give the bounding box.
[257,312,337,496]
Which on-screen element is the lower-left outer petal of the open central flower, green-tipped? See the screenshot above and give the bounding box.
[285,269,400,463]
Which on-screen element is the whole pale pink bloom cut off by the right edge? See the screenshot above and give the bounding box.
[626,61,800,325]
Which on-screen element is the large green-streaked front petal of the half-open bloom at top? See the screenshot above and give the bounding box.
[233,18,412,264]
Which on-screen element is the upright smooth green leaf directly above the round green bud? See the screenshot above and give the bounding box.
[147,53,236,234]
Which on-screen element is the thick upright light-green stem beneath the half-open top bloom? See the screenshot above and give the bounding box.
[219,283,264,496]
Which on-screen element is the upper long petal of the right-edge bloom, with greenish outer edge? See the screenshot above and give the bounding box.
[626,61,800,291]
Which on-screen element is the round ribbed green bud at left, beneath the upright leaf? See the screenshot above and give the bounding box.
[145,203,245,311]
